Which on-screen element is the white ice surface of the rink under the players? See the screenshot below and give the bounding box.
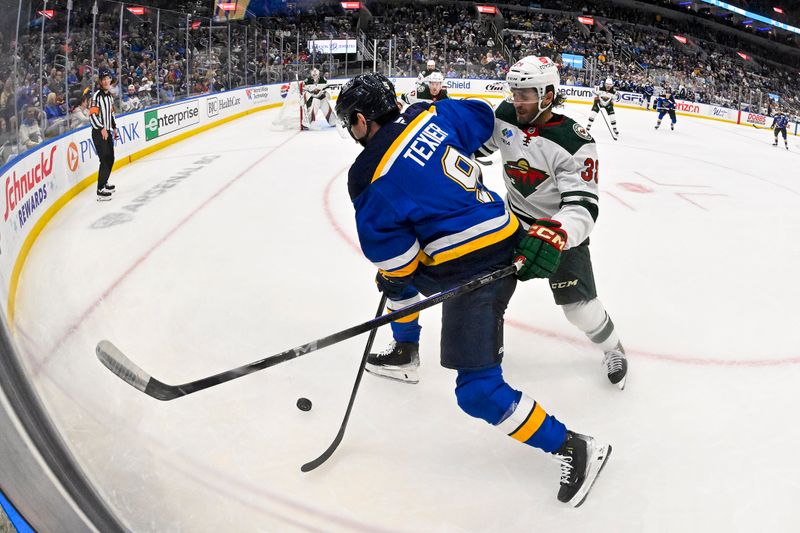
[10,105,800,533]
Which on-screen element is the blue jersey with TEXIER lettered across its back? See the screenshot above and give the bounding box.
[347,100,521,294]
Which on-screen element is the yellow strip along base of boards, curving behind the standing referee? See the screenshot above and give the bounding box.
[6,102,283,324]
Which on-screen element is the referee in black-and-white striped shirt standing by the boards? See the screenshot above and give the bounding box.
[89,69,119,201]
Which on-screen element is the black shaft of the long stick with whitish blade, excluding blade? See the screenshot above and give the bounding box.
[144,264,517,400]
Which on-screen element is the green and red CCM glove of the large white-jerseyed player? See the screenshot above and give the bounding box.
[514,218,567,281]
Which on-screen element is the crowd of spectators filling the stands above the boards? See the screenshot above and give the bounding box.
[0,0,800,164]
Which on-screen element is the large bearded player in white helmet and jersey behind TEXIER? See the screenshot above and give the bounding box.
[477,56,628,389]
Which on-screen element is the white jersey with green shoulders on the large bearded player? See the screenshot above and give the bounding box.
[476,102,599,248]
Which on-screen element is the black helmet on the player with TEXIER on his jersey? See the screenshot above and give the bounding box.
[336,74,399,131]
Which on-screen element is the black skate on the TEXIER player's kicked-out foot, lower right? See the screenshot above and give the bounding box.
[553,431,611,507]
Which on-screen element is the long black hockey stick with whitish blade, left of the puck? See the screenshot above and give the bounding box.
[95,263,522,401]
